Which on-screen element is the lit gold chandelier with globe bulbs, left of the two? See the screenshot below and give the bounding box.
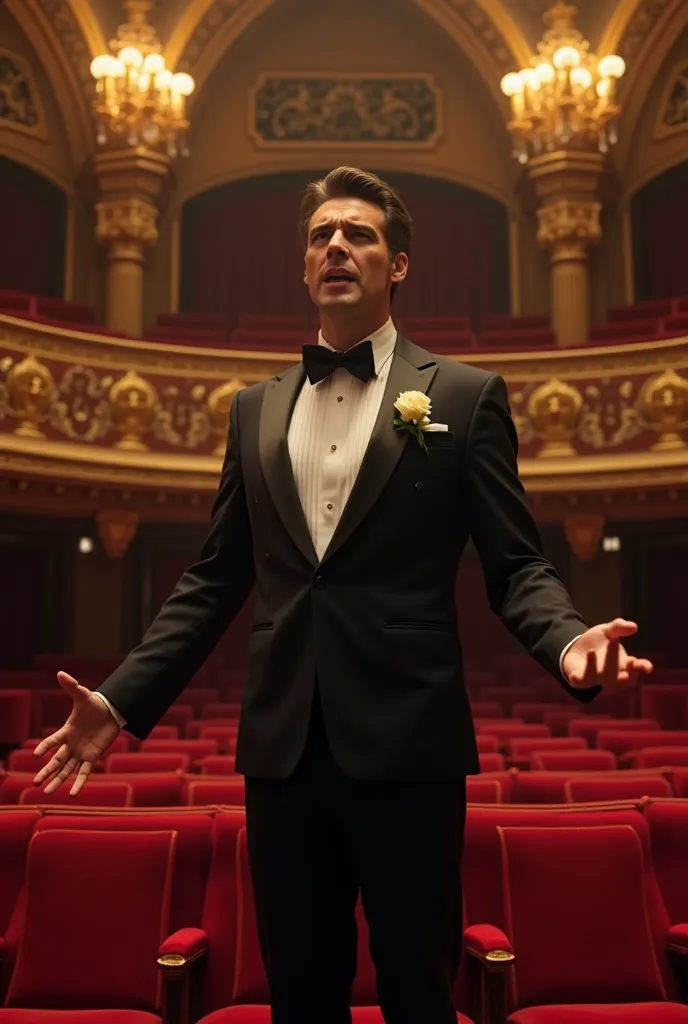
[91,0,195,158]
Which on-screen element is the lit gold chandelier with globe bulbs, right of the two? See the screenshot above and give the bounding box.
[502,0,626,164]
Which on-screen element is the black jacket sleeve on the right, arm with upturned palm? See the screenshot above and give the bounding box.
[466,375,600,701]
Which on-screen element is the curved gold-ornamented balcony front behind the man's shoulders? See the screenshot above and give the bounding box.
[0,316,688,518]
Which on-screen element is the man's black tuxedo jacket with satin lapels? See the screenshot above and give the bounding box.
[100,335,598,780]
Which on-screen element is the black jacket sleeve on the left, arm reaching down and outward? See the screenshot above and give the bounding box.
[98,394,254,739]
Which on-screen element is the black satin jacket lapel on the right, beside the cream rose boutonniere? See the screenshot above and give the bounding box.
[323,335,437,562]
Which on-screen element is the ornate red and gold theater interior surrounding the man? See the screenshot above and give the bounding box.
[0,0,688,1024]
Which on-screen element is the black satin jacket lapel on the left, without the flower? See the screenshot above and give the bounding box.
[258,364,317,565]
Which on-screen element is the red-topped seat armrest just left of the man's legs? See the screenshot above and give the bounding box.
[158,928,208,1024]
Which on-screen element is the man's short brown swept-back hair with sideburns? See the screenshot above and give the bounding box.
[299,167,413,276]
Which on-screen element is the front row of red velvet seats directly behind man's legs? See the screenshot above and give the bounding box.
[0,800,688,1024]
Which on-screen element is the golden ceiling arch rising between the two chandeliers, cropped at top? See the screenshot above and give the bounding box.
[166,0,530,105]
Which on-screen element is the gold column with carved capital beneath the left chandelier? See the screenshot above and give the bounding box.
[93,148,170,338]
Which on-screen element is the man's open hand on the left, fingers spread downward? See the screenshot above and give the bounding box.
[34,672,120,797]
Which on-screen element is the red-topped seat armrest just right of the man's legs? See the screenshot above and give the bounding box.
[464,925,514,1024]
